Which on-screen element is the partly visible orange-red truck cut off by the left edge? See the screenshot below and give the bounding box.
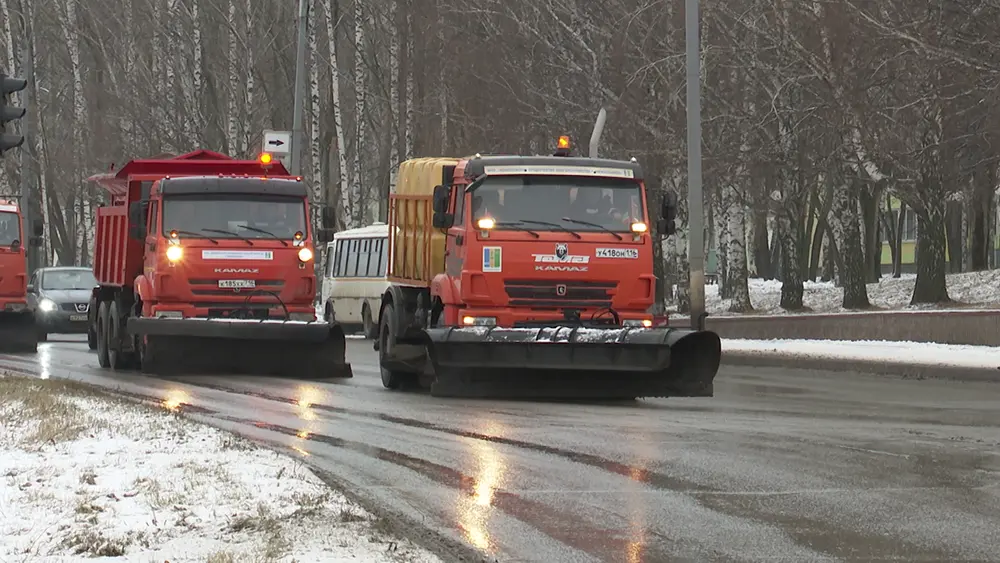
[0,196,42,353]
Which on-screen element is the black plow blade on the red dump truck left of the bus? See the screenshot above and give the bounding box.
[128,318,353,379]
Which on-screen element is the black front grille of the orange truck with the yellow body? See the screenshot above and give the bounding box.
[503,280,618,309]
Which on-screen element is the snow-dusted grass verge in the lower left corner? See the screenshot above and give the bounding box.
[0,375,439,563]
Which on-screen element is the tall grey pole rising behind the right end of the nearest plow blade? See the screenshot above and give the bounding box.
[684,0,706,330]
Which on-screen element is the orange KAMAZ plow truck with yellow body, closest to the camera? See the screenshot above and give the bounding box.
[375,137,722,399]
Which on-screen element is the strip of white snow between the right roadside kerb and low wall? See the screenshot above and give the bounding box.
[722,339,1000,369]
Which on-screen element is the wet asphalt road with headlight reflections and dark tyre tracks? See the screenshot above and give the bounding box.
[0,336,1000,563]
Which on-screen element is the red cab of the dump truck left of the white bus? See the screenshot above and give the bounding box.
[130,176,316,322]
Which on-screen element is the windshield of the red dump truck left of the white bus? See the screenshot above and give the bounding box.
[163,194,306,240]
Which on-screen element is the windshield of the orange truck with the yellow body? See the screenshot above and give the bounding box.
[472,176,644,233]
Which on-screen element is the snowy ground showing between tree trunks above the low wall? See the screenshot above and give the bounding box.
[705,270,1000,316]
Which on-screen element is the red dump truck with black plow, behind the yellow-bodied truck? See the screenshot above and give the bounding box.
[89,151,352,378]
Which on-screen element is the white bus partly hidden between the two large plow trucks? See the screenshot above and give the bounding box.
[321,222,389,339]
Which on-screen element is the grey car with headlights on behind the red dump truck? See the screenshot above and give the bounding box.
[28,267,97,341]
